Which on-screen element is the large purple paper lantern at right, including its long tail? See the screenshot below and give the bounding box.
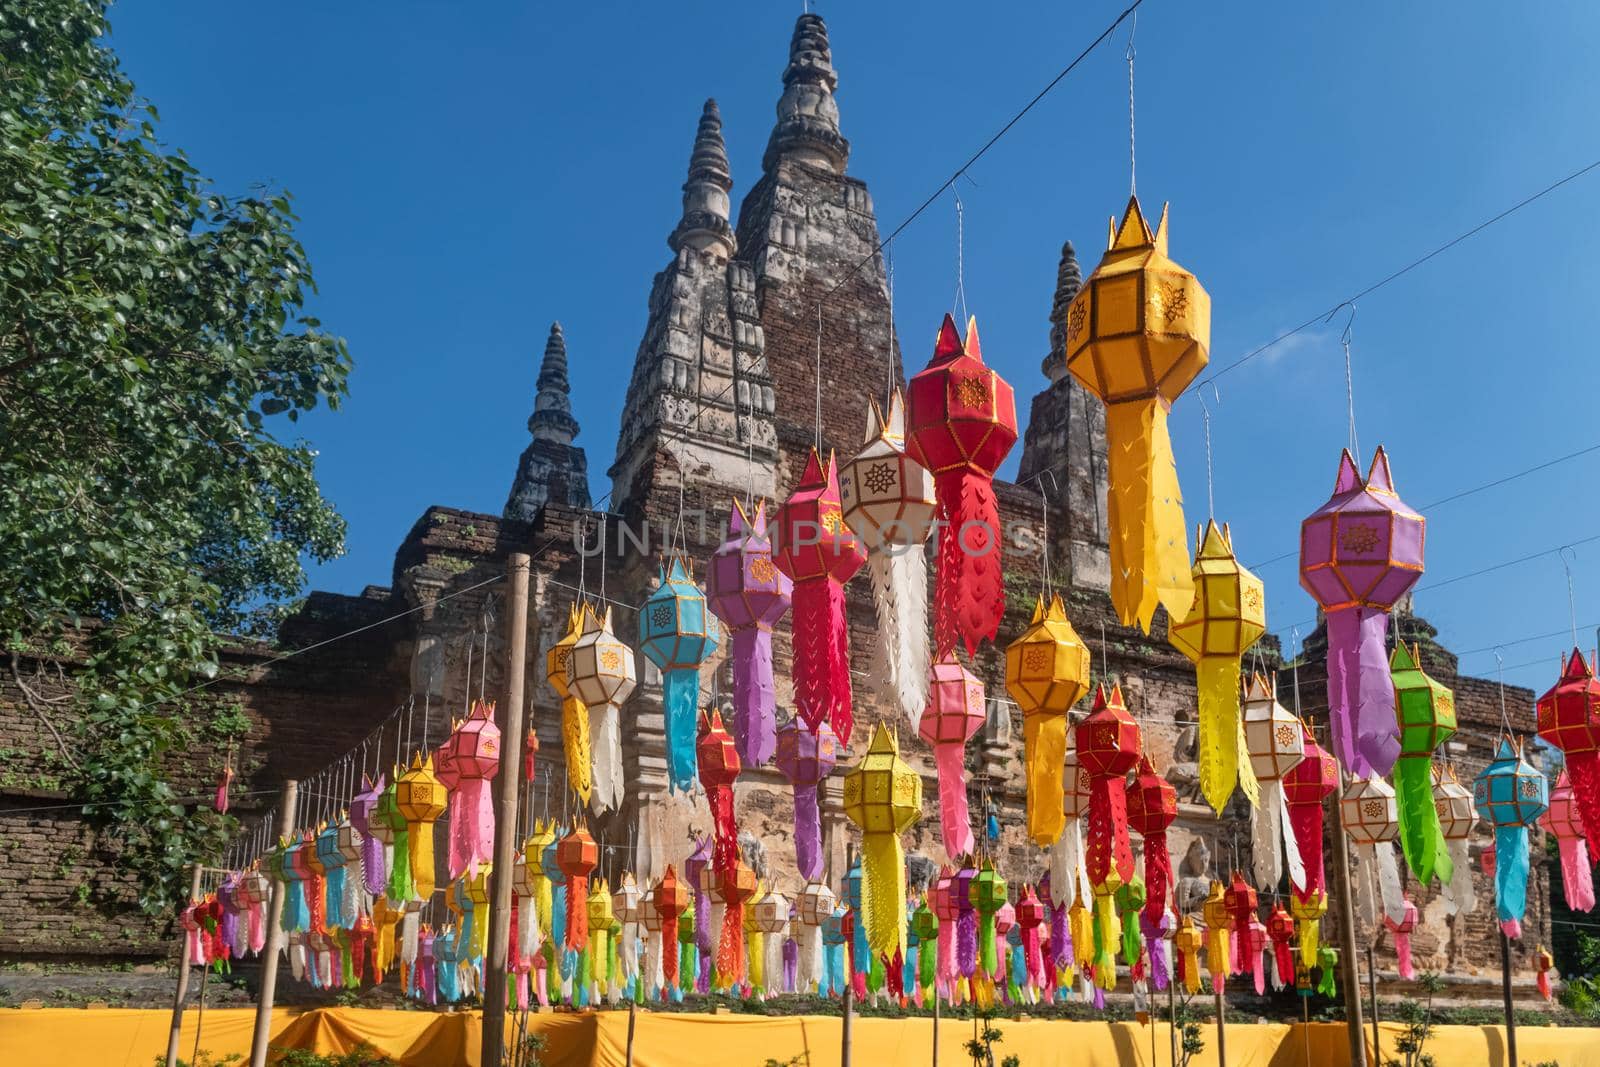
[1299,448,1424,777]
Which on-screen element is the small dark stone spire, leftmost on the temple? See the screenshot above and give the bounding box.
[506,323,589,522]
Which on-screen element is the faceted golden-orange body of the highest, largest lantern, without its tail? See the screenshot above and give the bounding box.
[1067,197,1211,403]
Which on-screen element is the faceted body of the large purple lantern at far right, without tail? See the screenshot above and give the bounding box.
[1301,446,1426,611]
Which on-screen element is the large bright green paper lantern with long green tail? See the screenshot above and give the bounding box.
[1389,641,1456,885]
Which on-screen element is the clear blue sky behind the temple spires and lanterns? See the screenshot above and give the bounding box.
[112,0,1600,689]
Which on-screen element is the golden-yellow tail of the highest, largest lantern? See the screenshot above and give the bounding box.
[1106,400,1195,633]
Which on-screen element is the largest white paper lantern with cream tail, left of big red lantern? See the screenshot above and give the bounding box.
[838,390,936,728]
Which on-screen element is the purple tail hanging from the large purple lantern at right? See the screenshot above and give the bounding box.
[1328,608,1400,777]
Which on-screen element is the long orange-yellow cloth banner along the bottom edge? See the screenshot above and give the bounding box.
[0,1008,1600,1067]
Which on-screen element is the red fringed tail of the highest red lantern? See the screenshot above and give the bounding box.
[933,467,1005,659]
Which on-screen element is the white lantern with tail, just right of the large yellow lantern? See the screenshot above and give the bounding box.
[1243,673,1306,889]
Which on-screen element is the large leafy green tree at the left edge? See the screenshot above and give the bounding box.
[0,0,349,909]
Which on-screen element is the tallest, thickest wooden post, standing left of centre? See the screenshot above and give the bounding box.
[478,552,534,1067]
